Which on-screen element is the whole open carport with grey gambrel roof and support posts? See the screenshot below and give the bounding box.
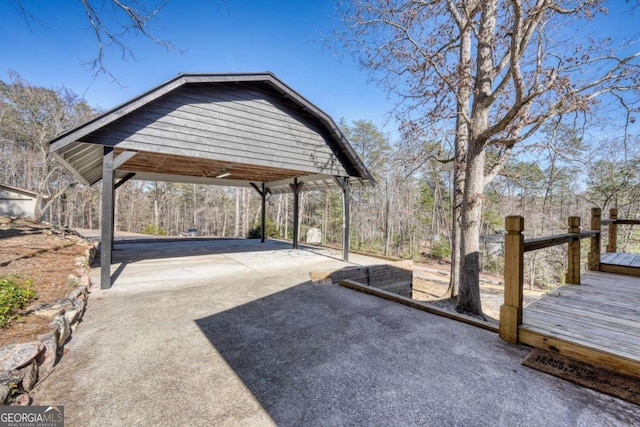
[49,72,373,289]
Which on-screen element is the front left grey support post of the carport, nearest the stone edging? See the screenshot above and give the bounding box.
[100,147,115,289]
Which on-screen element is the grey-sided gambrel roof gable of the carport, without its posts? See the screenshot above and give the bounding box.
[50,73,372,192]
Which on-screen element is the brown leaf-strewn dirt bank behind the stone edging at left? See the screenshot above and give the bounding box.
[0,217,88,346]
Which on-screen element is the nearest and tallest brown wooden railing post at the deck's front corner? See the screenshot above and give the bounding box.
[500,216,524,344]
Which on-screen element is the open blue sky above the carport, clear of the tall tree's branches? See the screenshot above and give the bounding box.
[0,0,640,142]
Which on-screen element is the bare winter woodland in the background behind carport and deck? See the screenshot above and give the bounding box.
[0,73,640,294]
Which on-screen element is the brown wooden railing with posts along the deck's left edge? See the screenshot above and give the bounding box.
[500,208,604,343]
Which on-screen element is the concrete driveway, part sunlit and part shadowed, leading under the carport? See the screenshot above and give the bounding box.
[34,240,640,426]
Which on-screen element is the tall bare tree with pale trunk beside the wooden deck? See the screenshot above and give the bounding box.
[341,0,640,314]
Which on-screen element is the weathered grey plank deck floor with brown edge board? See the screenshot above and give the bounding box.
[518,270,640,375]
